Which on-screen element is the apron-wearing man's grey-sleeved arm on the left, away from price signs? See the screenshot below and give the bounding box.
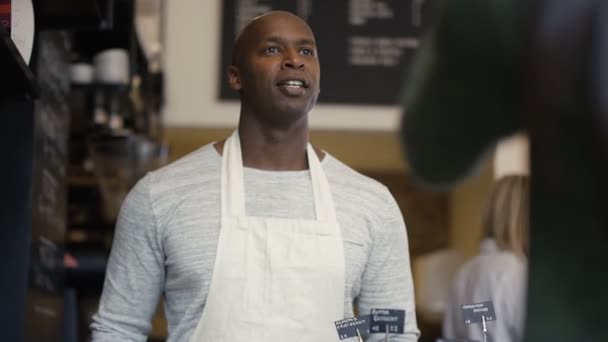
[91,175,165,342]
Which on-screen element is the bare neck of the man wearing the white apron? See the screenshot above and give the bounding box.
[238,117,309,171]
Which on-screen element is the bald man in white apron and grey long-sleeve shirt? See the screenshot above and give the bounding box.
[92,12,419,342]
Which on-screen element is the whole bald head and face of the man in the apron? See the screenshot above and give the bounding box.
[229,13,320,127]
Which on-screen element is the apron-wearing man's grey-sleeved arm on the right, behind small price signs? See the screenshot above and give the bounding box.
[358,190,420,342]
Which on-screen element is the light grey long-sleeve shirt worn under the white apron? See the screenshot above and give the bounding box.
[91,145,419,342]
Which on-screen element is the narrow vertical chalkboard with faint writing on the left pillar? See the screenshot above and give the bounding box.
[26,31,70,341]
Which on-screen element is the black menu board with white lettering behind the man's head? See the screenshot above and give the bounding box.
[219,0,437,105]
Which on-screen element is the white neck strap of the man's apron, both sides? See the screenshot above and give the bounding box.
[220,130,336,222]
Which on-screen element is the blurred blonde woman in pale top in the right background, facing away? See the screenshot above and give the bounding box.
[443,175,529,342]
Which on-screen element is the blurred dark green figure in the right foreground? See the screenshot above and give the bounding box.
[402,0,608,342]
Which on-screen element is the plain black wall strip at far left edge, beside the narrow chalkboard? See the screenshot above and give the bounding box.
[0,99,34,341]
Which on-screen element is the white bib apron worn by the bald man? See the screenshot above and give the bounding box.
[190,132,345,342]
